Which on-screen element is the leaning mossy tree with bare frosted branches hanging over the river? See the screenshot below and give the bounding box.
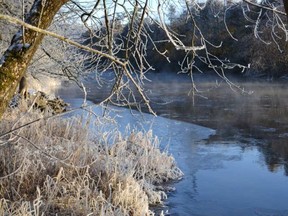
[0,0,287,118]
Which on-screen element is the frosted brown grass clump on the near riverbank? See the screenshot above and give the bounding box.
[0,104,183,216]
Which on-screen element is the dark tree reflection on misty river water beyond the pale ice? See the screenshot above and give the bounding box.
[60,74,288,175]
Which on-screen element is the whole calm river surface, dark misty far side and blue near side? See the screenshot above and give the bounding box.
[57,74,288,216]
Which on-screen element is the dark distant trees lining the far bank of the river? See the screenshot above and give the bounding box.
[83,0,288,80]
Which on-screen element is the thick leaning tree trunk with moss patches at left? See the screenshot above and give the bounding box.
[0,0,69,119]
